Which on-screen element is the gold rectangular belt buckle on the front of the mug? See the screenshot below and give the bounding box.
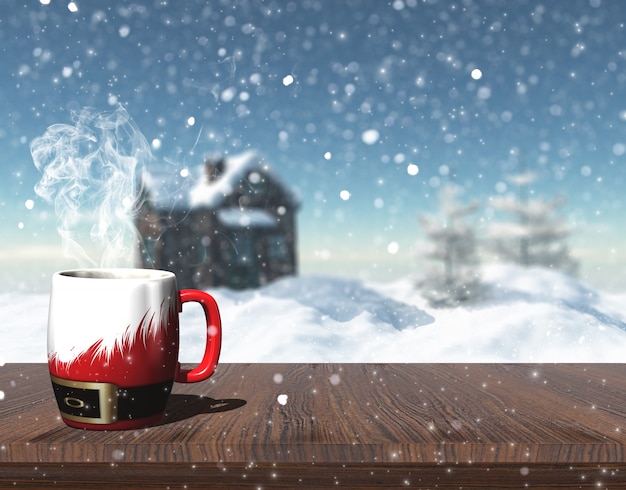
[50,375,118,424]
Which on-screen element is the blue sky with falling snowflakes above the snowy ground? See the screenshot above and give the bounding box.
[0,0,626,289]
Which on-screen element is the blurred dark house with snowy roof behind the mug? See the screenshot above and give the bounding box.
[137,152,299,289]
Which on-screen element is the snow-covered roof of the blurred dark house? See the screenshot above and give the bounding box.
[143,150,298,211]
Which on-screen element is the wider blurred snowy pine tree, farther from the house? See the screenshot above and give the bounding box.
[489,172,578,275]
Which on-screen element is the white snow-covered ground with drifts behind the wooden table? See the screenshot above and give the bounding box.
[0,265,626,364]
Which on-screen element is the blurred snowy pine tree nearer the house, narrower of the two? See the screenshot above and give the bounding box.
[419,183,480,306]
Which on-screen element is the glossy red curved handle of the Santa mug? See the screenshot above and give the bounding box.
[175,289,222,383]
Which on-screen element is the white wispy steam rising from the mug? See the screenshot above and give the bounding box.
[30,106,151,267]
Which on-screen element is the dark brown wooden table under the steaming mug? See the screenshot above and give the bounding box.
[0,364,626,489]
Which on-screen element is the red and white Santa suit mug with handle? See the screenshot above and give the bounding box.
[48,269,222,430]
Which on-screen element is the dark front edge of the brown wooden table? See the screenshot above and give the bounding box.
[0,463,626,490]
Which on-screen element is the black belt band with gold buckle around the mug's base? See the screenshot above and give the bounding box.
[51,376,174,424]
